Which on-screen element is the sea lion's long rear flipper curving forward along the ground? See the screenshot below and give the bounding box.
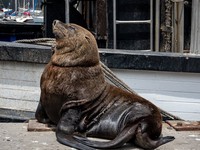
[73,124,138,149]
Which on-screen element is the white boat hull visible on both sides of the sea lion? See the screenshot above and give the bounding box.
[0,61,200,120]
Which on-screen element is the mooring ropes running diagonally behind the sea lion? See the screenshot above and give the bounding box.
[15,38,183,120]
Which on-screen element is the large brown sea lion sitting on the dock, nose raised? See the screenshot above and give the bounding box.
[35,20,174,150]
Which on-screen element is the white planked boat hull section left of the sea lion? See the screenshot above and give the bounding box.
[0,61,44,111]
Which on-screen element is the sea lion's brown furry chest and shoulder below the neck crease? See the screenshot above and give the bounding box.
[41,64,105,122]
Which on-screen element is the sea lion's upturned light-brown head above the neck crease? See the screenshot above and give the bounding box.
[51,20,99,66]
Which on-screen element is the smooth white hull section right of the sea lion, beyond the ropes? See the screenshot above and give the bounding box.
[113,70,200,120]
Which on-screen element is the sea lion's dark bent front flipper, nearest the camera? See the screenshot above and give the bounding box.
[56,109,95,150]
